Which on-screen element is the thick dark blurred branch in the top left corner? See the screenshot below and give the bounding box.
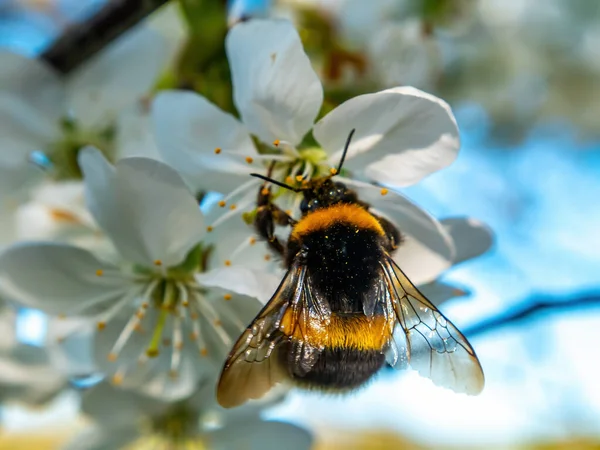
[41,0,168,73]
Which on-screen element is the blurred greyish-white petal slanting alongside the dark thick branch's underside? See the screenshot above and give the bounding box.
[67,27,168,127]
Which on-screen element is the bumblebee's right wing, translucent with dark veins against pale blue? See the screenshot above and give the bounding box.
[381,256,484,395]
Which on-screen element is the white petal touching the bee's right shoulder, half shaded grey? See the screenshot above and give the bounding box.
[353,182,454,285]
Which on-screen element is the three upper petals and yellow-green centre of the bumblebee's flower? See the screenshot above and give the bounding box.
[152,20,459,192]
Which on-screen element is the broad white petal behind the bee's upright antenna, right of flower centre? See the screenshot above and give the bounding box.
[314,87,460,187]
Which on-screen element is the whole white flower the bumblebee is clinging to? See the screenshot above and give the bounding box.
[152,20,459,282]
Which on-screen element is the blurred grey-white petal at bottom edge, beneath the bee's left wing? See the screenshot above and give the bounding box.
[207,420,313,450]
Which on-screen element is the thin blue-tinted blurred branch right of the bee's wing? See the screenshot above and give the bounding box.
[462,291,600,338]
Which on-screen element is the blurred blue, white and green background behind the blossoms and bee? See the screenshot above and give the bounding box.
[0,0,600,449]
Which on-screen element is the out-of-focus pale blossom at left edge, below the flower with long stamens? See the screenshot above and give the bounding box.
[0,304,66,405]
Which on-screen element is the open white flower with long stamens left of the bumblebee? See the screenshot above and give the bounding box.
[0,148,276,397]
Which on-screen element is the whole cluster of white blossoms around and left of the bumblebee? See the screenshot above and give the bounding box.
[0,14,491,449]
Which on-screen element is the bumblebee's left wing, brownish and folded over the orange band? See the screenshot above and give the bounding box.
[217,263,327,408]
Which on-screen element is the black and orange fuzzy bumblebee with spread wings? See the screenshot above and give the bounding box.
[217,130,484,407]
